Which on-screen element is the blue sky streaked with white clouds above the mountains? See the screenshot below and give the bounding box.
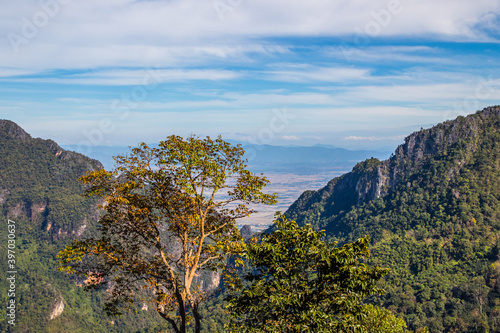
[0,0,500,150]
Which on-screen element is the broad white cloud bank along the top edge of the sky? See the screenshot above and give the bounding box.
[0,0,500,70]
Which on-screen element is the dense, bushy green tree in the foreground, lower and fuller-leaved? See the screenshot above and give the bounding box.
[228,215,406,333]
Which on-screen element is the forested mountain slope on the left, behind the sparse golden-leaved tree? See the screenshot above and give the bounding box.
[0,120,168,332]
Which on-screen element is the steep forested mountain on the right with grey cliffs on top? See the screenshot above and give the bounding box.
[286,106,500,332]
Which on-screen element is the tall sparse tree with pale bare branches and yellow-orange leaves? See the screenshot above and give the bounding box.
[59,136,276,333]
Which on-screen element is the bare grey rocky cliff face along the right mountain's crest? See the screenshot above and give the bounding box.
[287,106,500,228]
